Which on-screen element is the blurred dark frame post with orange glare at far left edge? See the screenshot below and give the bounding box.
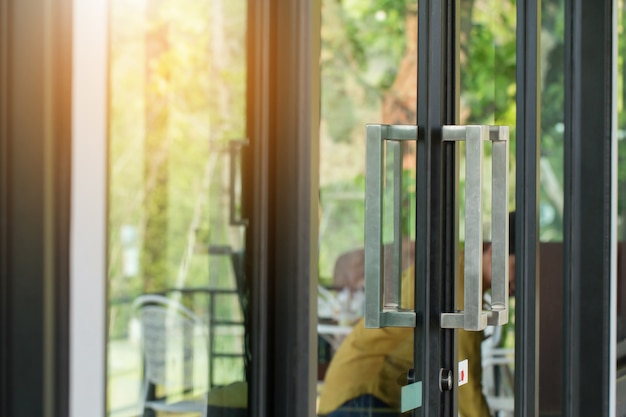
[0,0,72,417]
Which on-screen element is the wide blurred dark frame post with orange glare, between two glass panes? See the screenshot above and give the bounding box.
[243,0,321,417]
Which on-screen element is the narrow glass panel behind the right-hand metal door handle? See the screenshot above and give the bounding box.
[457,0,516,416]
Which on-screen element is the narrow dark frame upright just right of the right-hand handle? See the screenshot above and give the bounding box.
[515,0,541,417]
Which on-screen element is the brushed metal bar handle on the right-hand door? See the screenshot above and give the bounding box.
[441,125,509,331]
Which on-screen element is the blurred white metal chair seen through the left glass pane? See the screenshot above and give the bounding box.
[133,295,208,417]
